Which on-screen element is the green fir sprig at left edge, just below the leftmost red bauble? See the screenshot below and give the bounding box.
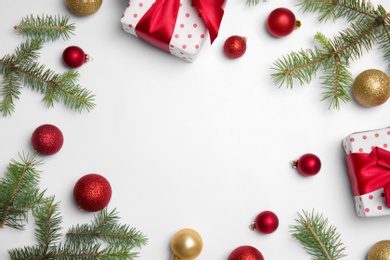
[0,154,45,229]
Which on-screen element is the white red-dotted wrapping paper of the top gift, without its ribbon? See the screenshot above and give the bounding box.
[121,0,221,62]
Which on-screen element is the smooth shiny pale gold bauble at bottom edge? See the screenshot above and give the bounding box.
[171,228,203,260]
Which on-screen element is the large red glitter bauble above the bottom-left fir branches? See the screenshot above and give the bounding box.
[73,173,112,212]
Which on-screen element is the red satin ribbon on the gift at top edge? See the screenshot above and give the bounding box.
[135,0,225,53]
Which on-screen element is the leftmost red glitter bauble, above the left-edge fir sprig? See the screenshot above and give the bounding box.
[31,124,64,155]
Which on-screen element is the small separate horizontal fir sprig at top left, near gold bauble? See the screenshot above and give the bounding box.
[14,15,76,41]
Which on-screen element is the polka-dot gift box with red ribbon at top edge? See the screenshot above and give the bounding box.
[121,0,225,62]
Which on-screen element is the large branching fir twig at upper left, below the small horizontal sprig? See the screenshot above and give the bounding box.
[0,39,95,116]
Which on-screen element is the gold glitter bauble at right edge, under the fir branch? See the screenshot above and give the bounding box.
[352,69,390,107]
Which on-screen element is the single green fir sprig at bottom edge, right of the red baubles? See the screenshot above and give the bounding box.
[290,210,346,260]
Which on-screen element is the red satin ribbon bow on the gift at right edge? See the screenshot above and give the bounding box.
[346,146,390,207]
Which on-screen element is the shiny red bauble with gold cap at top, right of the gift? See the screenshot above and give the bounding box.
[267,7,297,37]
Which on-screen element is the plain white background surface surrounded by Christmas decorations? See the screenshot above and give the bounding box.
[0,0,390,260]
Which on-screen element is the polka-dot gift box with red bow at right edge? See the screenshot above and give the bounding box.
[343,127,390,217]
